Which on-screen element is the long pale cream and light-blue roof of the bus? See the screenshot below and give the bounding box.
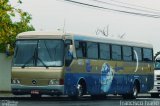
[17,31,153,48]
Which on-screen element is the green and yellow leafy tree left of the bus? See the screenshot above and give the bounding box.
[0,0,35,53]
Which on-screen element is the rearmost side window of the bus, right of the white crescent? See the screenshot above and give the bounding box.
[143,49,153,61]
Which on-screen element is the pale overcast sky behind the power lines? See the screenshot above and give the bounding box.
[10,0,160,53]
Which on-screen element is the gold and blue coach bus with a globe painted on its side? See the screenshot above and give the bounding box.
[11,31,154,98]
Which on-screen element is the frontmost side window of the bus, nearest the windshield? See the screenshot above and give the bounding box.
[75,41,86,58]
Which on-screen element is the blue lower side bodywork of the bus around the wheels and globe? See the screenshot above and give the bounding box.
[65,73,153,95]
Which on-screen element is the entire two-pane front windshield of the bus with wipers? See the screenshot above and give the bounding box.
[13,40,64,68]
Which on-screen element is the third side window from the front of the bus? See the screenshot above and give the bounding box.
[99,44,110,59]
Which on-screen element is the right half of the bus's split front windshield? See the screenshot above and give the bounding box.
[37,40,64,66]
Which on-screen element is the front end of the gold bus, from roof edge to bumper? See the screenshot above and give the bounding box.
[11,32,64,97]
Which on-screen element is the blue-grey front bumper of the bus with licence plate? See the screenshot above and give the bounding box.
[11,84,64,95]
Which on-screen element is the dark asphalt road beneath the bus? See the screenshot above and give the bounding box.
[0,95,160,106]
